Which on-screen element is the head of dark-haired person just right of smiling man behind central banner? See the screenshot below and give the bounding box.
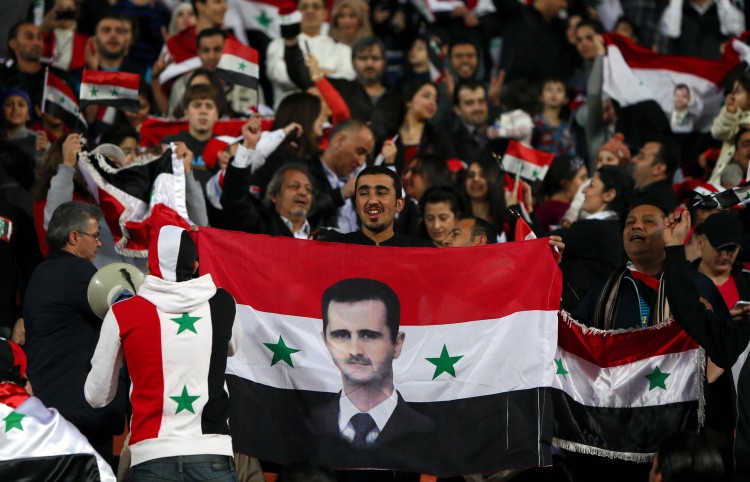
[419,186,461,248]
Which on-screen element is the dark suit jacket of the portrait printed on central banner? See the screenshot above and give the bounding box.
[311,391,437,472]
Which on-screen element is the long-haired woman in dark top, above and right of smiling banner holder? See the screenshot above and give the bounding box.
[394,81,455,173]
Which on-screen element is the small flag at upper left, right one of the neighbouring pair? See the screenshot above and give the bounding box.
[81,70,141,112]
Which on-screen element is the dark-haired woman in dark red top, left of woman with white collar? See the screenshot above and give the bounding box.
[536,155,588,232]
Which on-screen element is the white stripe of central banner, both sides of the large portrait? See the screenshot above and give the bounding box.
[227,305,557,402]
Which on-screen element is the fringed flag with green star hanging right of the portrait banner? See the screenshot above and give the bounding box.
[552,312,705,462]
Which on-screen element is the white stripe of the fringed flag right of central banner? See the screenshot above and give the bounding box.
[553,347,703,408]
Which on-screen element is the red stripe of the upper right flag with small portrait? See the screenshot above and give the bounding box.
[604,33,737,85]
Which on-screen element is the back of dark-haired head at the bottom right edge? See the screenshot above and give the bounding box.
[656,431,724,482]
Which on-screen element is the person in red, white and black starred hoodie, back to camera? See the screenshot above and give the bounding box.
[84,226,242,480]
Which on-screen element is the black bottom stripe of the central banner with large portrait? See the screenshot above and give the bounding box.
[227,375,552,476]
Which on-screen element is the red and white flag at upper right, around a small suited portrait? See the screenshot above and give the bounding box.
[604,33,738,131]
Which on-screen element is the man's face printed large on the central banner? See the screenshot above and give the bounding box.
[323,300,405,393]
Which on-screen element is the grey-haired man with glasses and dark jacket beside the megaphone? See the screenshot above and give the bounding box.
[23,201,127,461]
